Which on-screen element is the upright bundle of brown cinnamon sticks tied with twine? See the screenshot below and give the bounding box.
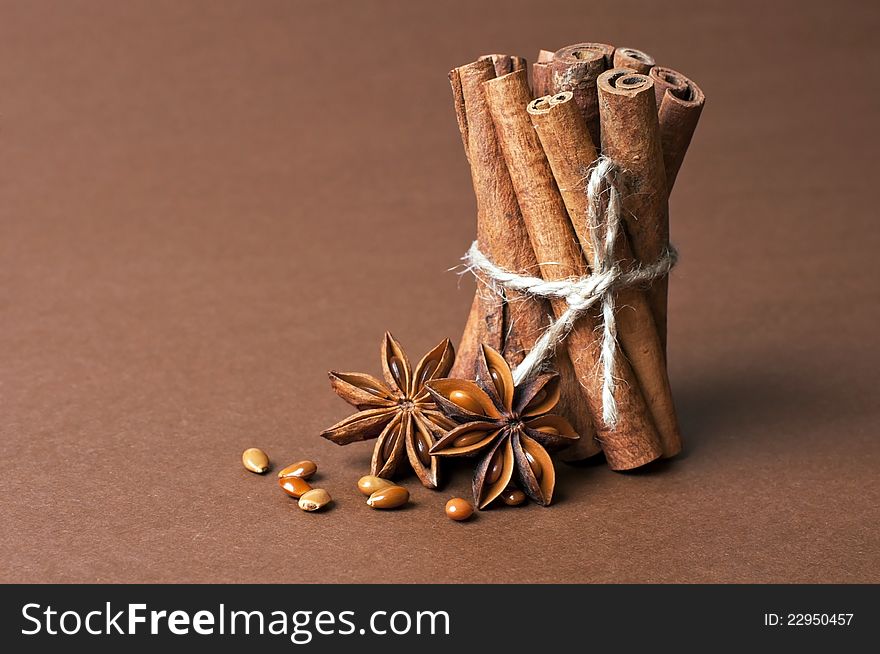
[449,43,705,470]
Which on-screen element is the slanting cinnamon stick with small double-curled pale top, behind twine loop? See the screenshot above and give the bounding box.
[528,92,681,457]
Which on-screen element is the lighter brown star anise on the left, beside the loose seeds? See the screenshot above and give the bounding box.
[321,332,455,488]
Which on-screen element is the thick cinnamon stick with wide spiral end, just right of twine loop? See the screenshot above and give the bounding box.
[598,68,669,353]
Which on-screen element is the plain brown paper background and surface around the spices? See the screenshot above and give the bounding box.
[0,0,880,582]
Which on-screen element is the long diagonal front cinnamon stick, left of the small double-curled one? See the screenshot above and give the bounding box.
[483,71,662,470]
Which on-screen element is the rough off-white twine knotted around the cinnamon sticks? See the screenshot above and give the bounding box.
[462,157,678,429]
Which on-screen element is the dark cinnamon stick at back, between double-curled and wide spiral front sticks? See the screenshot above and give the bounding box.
[545,43,614,143]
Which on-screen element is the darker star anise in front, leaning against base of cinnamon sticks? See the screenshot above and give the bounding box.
[426,345,578,509]
